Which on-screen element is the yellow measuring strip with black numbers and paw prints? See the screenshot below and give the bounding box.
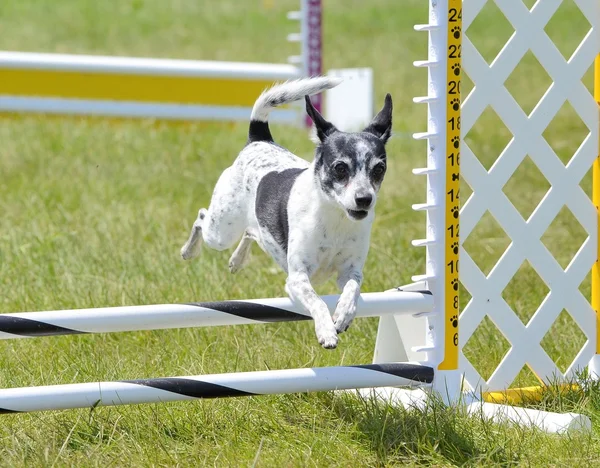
[439,0,462,370]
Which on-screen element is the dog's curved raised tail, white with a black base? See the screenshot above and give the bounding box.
[248,76,342,143]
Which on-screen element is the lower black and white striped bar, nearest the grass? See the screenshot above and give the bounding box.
[0,363,434,414]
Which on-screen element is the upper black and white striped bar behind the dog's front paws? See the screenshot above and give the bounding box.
[0,290,433,339]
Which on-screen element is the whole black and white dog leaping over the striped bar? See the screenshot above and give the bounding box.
[181,77,392,349]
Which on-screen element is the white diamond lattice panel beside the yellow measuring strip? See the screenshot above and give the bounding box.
[460,0,600,390]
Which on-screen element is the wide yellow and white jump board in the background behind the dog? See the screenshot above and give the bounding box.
[0,51,302,123]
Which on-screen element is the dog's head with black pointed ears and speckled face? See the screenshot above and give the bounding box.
[306,94,392,220]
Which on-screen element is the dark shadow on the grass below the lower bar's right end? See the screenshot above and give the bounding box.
[331,394,520,466]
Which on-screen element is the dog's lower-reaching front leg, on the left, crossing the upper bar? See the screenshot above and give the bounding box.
[285,272,338,349]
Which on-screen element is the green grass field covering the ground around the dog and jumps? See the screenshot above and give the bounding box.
[0,0,600,467]
